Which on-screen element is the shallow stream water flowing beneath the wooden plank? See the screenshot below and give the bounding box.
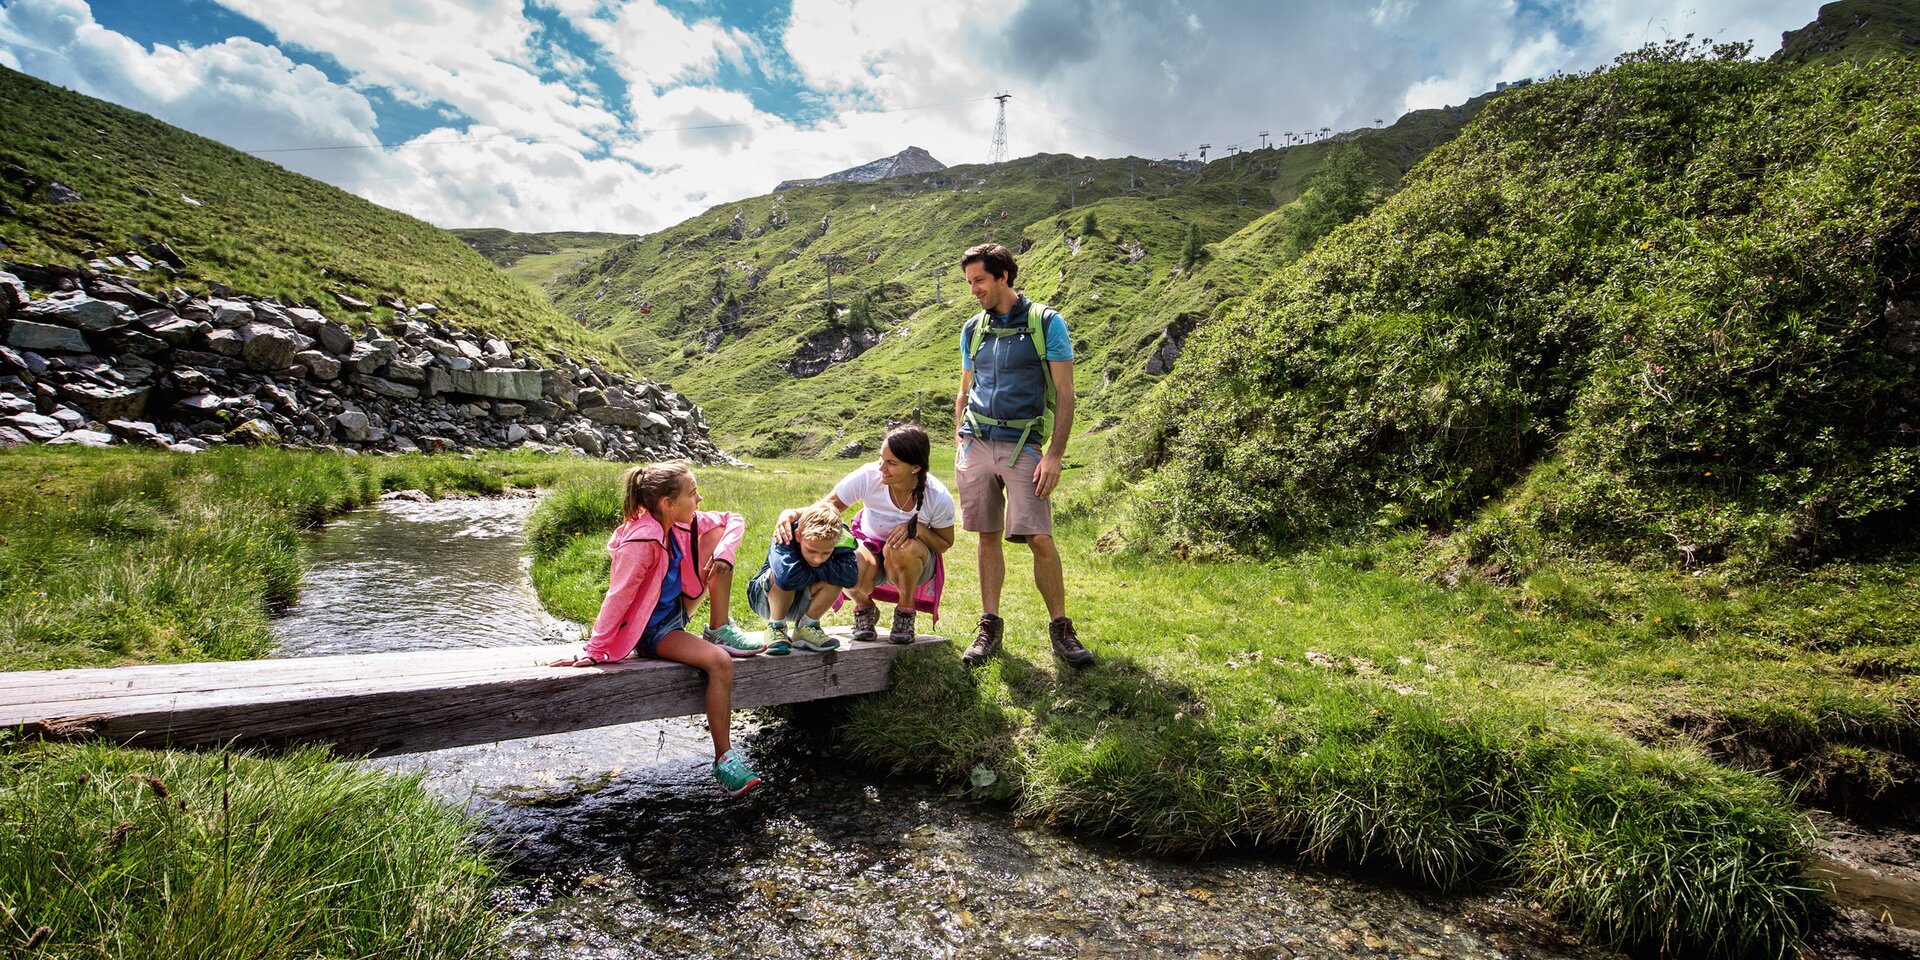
[266,499,1904,960]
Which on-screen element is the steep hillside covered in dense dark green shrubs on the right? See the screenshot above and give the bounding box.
[1140,44,1920,564]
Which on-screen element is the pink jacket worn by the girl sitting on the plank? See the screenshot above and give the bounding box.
[586,511,747,662]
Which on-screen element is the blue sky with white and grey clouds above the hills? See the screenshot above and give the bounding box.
[0,0,1820,232]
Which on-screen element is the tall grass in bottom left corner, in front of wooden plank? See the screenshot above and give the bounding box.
[0,741,505,960]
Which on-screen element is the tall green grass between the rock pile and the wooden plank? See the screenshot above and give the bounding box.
[0,447,606,670]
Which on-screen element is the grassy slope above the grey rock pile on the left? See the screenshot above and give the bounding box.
[0,69,609,353]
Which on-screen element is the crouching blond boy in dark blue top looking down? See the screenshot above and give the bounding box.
[747,503,860,657]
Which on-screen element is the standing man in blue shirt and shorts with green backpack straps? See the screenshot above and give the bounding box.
[954,244,1092,666]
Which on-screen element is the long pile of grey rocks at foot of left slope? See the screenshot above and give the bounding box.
[0,257,728,463]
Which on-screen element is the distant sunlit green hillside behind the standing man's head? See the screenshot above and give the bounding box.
[533,98,1484,453]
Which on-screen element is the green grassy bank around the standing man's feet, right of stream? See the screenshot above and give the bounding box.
[532,438,1920,956]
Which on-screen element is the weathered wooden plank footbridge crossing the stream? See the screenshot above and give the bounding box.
[0,628,945,756]
